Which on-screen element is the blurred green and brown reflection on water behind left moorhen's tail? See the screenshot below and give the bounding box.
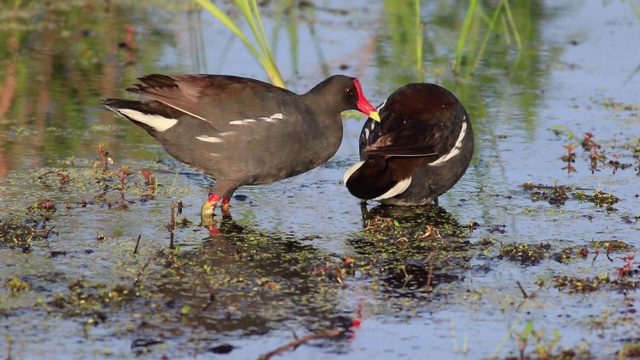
[0,1,191,176]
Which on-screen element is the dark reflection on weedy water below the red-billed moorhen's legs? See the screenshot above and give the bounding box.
[138,216,352,351]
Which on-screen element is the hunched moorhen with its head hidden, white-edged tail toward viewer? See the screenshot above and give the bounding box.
[344,83,474,205]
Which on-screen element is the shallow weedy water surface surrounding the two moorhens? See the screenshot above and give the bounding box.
[0,1,640,359]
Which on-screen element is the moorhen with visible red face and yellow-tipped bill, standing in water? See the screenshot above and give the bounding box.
[103,74,379,217]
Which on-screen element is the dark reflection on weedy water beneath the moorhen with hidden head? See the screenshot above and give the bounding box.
[349,205,477,298]
